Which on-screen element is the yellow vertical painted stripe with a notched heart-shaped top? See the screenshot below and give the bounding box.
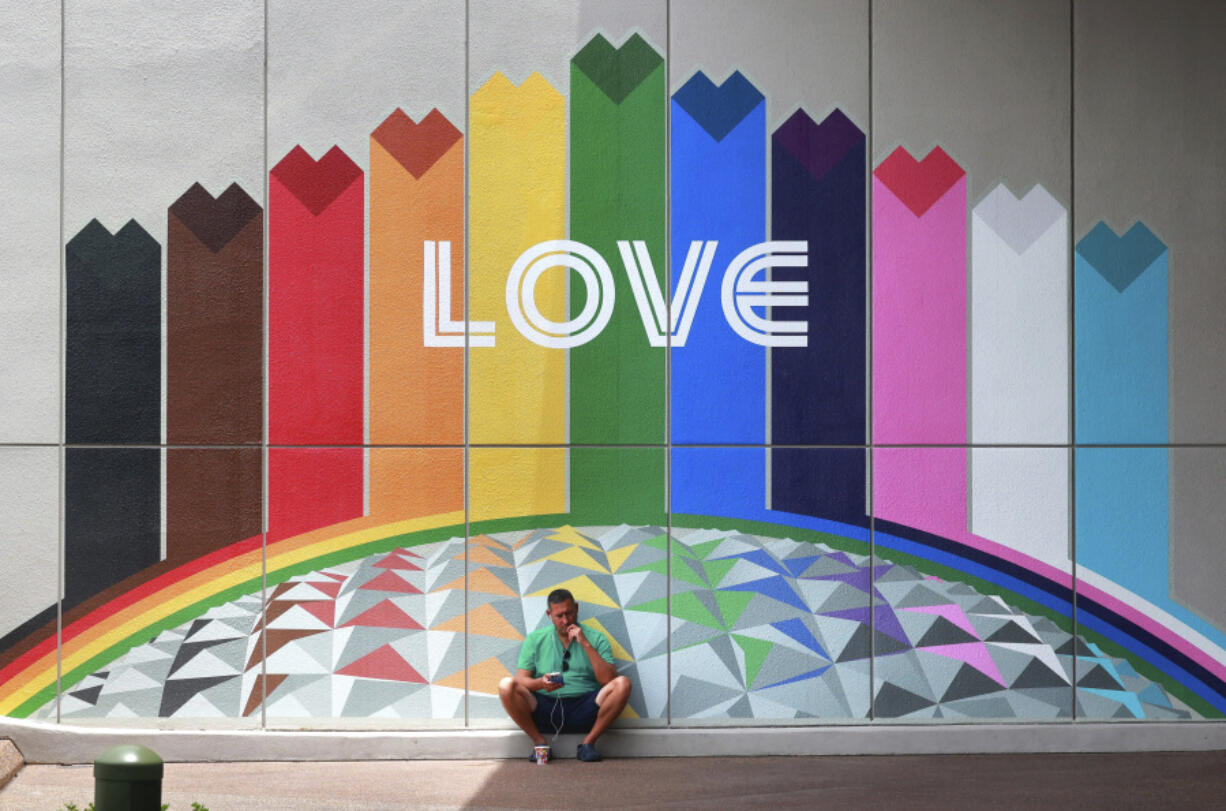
[468,74,568,521]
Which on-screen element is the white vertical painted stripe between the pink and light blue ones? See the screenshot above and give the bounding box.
[970,184,1072,570]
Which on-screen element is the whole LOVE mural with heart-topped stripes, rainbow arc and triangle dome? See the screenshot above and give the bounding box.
[0,0,1226,725]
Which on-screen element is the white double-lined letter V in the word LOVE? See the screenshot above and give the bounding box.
[617,239,718,347]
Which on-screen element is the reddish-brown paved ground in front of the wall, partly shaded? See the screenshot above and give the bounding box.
[0,752,1226,811]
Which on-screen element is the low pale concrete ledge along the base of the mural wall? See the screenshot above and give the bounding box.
[0,719,1226,764]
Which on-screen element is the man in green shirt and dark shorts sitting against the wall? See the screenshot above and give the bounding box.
[498,588,630,762]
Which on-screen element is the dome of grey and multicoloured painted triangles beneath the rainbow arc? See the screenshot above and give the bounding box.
[39,526,1194,720]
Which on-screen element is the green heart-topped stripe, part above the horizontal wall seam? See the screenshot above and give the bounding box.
[570,34,668,445]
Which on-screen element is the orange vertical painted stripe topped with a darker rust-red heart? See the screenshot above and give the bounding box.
[369,109,465,521]
